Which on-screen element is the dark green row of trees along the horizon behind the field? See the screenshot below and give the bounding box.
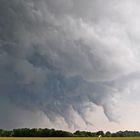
[0,128,140,137]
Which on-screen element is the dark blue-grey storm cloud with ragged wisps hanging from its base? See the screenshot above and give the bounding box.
[0,0,139,129]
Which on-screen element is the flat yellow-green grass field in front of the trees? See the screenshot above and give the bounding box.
[0,137,140,140]
